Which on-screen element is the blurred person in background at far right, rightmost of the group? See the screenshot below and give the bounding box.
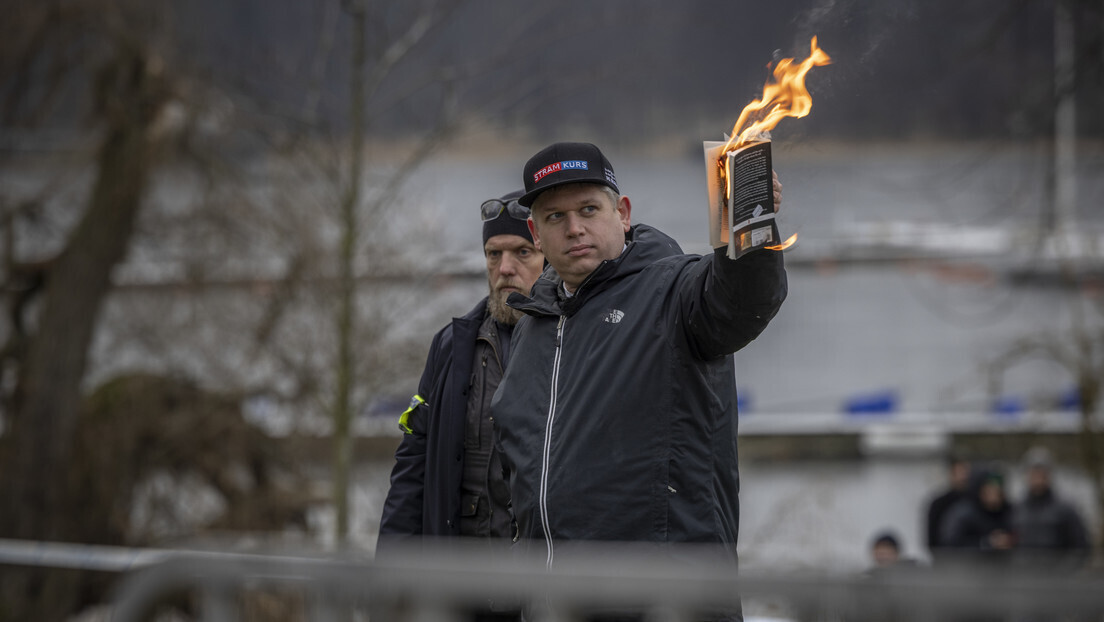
[1012,447,1090,572]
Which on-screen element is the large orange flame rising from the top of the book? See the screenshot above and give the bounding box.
[721,36,831,154]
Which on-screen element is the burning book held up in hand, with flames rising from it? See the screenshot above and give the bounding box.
[703,36,831,259]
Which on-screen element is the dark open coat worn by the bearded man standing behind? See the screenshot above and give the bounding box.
[380,298,487,541]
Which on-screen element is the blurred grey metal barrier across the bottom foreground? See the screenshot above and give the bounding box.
[99,545,1104,622]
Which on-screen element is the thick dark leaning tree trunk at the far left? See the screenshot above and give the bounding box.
[0,43,164,620]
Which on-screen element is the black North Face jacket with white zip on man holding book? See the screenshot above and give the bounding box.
[491,225,786,562]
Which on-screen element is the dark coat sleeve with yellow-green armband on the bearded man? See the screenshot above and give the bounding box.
[378,333,443,541]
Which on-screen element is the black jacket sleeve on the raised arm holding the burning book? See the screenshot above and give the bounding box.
[681,247,787,359]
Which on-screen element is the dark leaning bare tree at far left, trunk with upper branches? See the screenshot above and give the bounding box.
[0,2,178,619]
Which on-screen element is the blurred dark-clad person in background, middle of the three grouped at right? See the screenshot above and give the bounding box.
[940,467,1016,567]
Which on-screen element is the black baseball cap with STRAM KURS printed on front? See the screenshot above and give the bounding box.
[518,143,620,208]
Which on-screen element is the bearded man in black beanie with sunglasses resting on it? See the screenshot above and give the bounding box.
[380,191,544,546]
